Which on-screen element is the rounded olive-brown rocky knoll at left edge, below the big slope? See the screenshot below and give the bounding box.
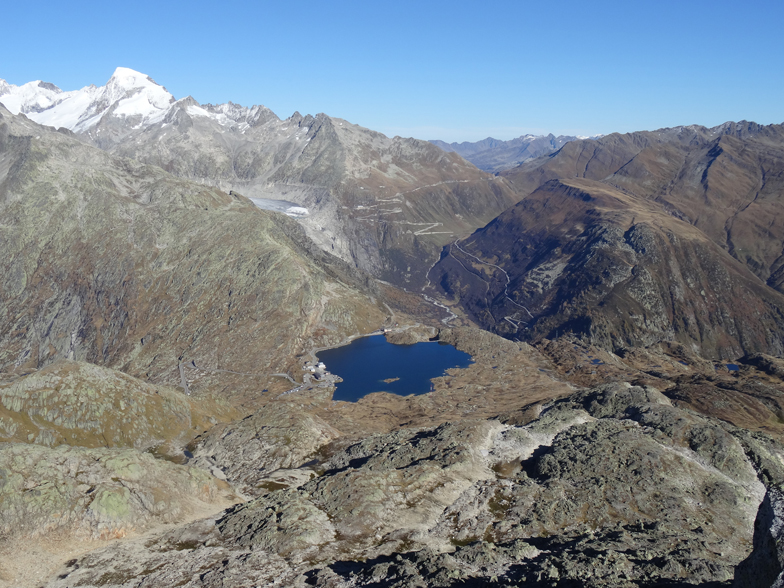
[0,360,233,453]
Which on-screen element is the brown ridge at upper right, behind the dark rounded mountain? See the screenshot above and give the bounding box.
[504,122,784,289]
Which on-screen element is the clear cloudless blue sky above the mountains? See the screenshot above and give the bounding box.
[0,0,784,141]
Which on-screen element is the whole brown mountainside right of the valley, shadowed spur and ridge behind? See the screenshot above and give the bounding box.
[429,123,784,358]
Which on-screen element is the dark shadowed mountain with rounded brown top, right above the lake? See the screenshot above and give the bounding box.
[430,179,784,358]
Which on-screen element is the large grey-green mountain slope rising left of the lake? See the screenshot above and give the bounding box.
[0,104,387,400]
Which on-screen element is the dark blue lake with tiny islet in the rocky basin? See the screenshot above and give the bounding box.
[318,335,473,402]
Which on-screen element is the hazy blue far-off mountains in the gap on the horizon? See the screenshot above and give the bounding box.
[430,133,601,172]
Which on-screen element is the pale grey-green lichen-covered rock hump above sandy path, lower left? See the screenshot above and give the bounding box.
[0,443,236,541]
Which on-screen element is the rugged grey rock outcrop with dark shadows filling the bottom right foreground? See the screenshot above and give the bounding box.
[36,383,784,587]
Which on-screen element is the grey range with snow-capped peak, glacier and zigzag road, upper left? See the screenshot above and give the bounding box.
[0,68,517,287]
